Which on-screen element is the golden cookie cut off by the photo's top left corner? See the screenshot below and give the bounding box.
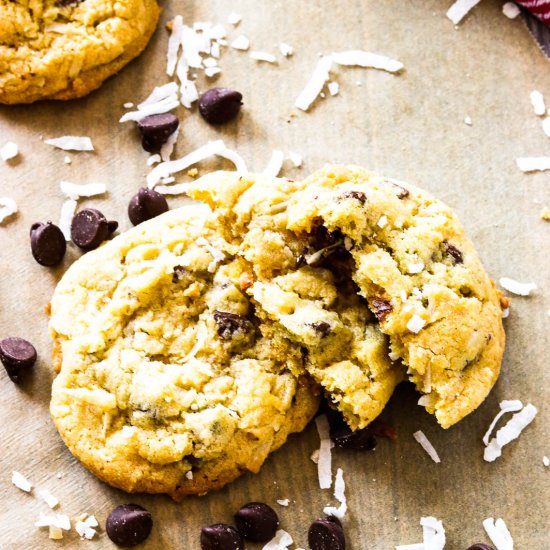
[0,0,160,104]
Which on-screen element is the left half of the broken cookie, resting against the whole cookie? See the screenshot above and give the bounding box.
[189,172,404,429]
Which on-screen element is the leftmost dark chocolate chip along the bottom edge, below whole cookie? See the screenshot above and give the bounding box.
[105,504,153,547]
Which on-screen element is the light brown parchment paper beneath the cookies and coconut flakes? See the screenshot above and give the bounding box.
[0,0,550,550]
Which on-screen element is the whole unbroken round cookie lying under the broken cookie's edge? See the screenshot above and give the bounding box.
[50,205,319,500]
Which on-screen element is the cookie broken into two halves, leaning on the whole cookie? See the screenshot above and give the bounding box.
[190,166,505,429]
